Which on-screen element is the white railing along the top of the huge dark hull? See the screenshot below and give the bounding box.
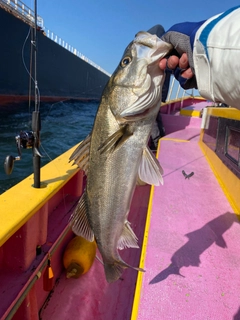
[0,0,111,76]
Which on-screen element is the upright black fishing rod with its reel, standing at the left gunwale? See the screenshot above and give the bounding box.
[4,0,42,188]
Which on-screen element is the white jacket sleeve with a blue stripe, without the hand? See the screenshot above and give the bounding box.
[193,6,240,109]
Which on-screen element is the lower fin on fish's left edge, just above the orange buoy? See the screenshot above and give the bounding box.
[70,192,94,242]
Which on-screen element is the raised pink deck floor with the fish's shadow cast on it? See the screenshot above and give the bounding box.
[137,134,240,320]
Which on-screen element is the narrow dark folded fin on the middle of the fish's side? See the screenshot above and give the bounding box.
[98,125,132,154]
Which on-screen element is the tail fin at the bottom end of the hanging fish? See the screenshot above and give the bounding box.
[104,261,145,283]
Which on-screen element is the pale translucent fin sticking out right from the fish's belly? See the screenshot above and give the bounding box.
[138,147,163,186]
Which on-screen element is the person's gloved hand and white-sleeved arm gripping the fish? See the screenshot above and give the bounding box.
[159,6,240,109]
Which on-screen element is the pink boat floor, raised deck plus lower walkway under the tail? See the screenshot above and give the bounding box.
[40,101,240,320]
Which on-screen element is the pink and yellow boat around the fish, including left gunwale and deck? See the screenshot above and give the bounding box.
[0,99,240,320]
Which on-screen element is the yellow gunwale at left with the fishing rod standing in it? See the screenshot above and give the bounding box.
[0,146,79,246]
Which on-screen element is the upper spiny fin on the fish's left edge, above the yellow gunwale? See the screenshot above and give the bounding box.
[69,134,91,174]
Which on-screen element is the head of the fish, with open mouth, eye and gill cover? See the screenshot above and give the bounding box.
[107,31,172,121]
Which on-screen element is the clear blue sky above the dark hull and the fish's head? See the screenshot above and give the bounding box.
[22,0,239,73]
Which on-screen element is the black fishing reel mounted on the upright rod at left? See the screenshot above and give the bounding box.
[4,131,42,175]
